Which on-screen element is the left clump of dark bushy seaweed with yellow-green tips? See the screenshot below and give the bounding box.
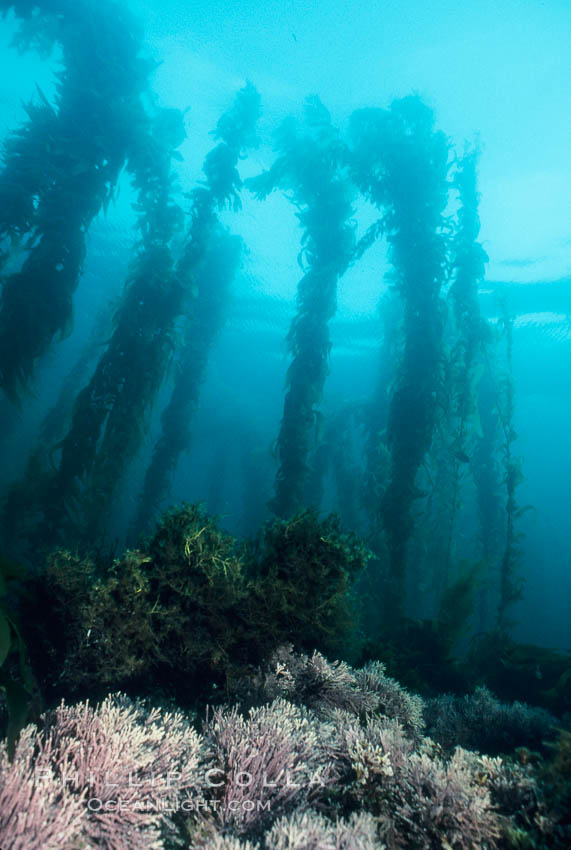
[21,506,246,703]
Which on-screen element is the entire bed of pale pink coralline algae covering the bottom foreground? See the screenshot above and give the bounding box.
[0,649,557,850]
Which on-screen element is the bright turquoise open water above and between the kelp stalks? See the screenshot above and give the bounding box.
[0,3,571,647]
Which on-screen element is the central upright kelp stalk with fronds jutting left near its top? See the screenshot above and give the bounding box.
[248,97,354,518]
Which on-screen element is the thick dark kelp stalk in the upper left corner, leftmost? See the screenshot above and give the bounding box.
[0,0,150,400]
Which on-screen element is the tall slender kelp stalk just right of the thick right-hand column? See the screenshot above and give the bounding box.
[407,151,489,616]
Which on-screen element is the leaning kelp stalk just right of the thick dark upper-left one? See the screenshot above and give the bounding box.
[35,109,187,539]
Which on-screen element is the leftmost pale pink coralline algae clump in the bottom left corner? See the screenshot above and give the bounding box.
[0,694,206,850]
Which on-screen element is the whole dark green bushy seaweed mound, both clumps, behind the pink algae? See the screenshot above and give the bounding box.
[19,505,368,703]
